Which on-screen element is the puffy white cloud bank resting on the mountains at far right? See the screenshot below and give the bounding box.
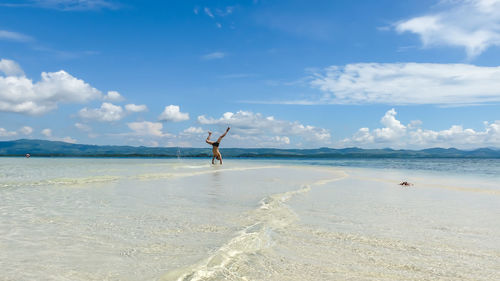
[339,109,500,149]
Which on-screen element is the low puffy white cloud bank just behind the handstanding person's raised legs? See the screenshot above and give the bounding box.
[198,111,331,146]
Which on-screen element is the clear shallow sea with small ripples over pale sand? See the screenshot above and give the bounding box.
[0,157,500,281]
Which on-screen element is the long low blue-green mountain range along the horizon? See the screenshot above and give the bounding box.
[0,139,500,158]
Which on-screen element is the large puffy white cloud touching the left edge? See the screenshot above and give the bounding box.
[0,60,101,115]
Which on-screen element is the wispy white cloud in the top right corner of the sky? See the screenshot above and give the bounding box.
[395,0,500,58]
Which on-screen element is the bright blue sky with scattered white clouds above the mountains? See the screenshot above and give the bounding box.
[0,0,500,149]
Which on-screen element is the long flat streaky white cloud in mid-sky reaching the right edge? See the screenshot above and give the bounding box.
[311,63,500,105]
